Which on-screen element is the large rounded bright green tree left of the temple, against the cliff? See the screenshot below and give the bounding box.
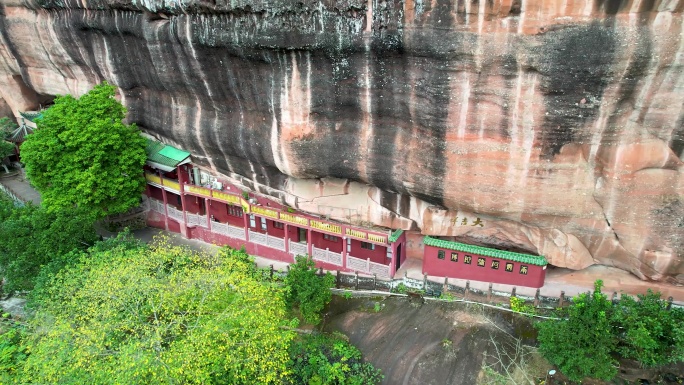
[21,82,146,217]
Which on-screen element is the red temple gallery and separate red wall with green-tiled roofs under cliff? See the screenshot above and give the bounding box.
[145,139,546,287]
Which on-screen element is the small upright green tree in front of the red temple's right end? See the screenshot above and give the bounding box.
[285,255,335,325]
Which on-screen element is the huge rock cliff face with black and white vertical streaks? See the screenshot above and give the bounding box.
[0,0,684,280]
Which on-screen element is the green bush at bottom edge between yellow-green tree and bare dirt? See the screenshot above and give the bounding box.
[287,335,383,385]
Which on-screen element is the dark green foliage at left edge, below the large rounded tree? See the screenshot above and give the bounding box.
[0,200,98,292]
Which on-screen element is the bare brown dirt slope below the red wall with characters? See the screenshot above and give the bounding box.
[324,296,547,385]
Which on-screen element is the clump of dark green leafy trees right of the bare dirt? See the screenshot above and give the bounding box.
[538,280,684,381]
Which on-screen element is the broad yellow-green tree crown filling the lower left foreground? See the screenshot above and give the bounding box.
[15,241,296,385]
